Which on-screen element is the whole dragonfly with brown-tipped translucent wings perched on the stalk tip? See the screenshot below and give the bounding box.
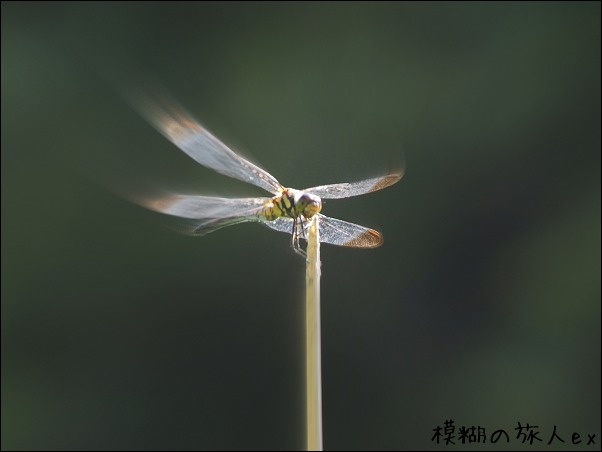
[130,94,403,256]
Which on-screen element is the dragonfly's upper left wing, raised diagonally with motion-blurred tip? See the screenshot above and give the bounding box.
[129,92,281,194]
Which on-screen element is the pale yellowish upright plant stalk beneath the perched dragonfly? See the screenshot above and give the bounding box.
[305,216,322,450]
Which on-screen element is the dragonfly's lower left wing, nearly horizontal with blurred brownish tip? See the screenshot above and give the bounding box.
[135,195,270,235]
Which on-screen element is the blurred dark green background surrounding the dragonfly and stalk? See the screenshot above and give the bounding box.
[1,2,602,450]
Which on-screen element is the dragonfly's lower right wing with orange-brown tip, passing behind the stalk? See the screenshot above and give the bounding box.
[263,214,384,248]
